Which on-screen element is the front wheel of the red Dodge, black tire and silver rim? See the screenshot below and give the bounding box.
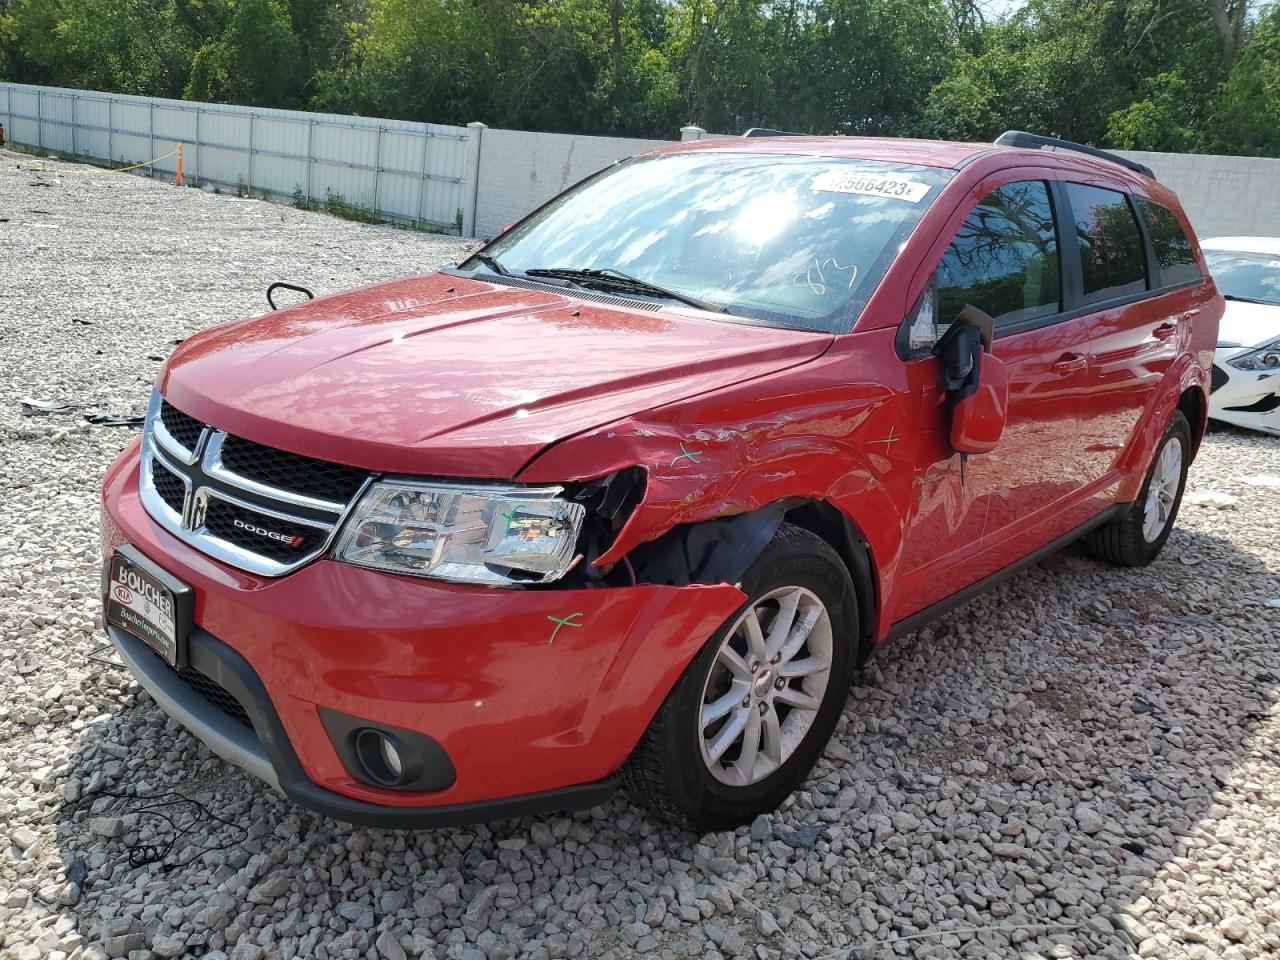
[622,524,858,829]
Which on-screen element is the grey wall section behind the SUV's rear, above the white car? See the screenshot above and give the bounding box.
[1117,151,1280,239]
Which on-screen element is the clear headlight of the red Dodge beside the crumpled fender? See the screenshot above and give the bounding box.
[334,480,586,586]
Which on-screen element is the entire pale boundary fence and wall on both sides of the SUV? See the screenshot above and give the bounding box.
[0,83,1280,244]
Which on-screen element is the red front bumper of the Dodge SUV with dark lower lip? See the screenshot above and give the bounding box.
[102,447,744,827]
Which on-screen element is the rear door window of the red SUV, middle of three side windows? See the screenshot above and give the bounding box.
[1065,183,1147,303]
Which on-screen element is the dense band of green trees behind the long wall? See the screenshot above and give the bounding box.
[0,0,1280,155]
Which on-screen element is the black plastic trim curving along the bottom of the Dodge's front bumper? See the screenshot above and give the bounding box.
[113,627,618,829]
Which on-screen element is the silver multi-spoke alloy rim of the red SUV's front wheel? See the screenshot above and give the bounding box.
[698,586,833,787]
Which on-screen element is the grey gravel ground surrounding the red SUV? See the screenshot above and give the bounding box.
[0,155,1280,960]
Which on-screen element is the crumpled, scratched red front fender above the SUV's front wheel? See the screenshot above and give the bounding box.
[520,330,919,635]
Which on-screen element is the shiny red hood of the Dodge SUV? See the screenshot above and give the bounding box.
[160,274,832,479]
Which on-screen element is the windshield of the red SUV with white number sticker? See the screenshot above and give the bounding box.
[466,151,951,333]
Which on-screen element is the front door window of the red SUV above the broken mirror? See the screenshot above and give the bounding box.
[937,180,1061,329]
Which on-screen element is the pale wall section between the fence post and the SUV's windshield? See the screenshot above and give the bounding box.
[476,128,668,237]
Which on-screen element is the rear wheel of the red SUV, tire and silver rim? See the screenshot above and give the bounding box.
[1088,410,1192,567]
